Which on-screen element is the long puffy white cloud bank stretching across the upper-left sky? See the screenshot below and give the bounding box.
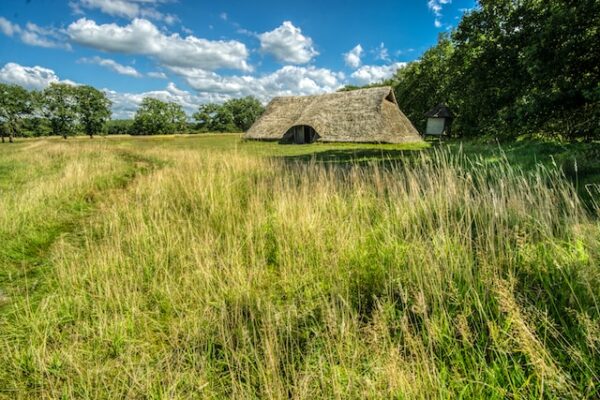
[67,18,251,71]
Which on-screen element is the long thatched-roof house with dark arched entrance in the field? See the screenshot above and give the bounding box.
[244,87,421,143]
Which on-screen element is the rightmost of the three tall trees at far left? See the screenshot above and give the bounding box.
[75,86,111,139]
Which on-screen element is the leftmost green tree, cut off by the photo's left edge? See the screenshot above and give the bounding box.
[0,83,33,143]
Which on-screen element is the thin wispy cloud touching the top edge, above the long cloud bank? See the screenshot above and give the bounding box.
[70,0,178,24]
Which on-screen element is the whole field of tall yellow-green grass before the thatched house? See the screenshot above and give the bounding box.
[0,135,600,399]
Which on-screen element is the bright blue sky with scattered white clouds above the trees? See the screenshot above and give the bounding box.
[0,0,475,117]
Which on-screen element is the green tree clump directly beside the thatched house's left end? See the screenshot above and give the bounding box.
[193,96,264,132]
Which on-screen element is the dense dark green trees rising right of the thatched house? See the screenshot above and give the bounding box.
[384,0,600,140]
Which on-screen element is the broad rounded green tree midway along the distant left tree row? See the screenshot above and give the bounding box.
[131,97,186,135]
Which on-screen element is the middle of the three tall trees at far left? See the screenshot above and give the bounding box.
[42,83,77,139]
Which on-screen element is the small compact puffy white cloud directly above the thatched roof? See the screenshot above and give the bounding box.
[258,21,319,64]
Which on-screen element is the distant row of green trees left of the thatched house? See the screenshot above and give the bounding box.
[0,83,264,143]
